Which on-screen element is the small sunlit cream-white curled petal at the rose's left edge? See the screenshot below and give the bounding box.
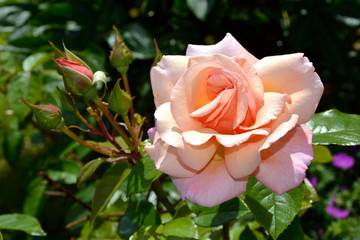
[155,102,183,147]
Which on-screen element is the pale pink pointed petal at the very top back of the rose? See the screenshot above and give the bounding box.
[186,33,258,64]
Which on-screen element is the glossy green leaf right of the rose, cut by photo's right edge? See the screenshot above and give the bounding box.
[306,109,360,146]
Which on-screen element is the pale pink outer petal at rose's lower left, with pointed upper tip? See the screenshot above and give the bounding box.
[145,133,195,177]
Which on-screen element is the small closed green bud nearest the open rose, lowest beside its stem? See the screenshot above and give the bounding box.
[109,81,132,115]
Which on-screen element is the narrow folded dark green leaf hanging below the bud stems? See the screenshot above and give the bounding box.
[91,162,131,222]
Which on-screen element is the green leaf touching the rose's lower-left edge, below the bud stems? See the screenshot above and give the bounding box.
[127,155,162,194]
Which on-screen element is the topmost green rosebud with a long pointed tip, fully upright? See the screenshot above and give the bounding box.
[110,26,134,74]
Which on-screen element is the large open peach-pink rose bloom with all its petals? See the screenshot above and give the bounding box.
[146,33,323,207]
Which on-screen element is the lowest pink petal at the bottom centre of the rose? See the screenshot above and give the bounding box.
[172,161,247,207]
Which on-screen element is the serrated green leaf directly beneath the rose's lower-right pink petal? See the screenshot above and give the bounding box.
[245,176,304,239]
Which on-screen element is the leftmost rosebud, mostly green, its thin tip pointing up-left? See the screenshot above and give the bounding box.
[21,98,65,130]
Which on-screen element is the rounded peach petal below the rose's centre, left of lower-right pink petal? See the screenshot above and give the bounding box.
[225,139,264,179]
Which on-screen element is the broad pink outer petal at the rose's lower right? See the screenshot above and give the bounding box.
[253,125,314,194]
